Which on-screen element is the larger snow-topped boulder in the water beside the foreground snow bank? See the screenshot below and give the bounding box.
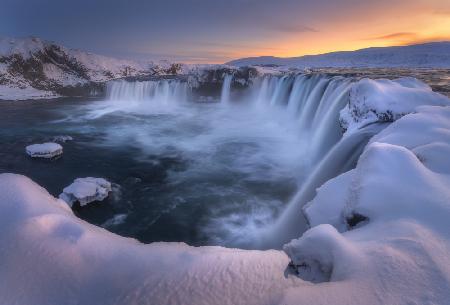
[59,177,112,206]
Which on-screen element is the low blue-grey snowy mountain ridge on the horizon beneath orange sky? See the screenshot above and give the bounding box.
[227,42,450,68]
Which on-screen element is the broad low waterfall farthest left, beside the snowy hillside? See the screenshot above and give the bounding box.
[106,80,188,105]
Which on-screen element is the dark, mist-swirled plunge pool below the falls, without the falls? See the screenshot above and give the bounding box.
[0,99,305,248]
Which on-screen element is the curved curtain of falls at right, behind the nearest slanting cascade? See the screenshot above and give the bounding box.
[252,74,351,167]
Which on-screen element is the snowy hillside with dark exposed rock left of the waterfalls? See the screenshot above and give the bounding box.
[0,37,183,99]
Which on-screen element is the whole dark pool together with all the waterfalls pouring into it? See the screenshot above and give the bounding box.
[0,75,380,248]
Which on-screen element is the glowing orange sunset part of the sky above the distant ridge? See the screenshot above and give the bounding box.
[209,0,450,61]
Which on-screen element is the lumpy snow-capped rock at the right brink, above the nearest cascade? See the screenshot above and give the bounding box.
[340,77,450,132]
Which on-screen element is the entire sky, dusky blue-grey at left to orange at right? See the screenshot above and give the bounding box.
[0,0,450,63]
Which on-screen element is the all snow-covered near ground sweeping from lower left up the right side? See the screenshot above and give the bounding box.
[0,75,450,305]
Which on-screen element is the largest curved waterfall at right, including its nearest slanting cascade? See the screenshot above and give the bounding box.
[248,74,384,248]
